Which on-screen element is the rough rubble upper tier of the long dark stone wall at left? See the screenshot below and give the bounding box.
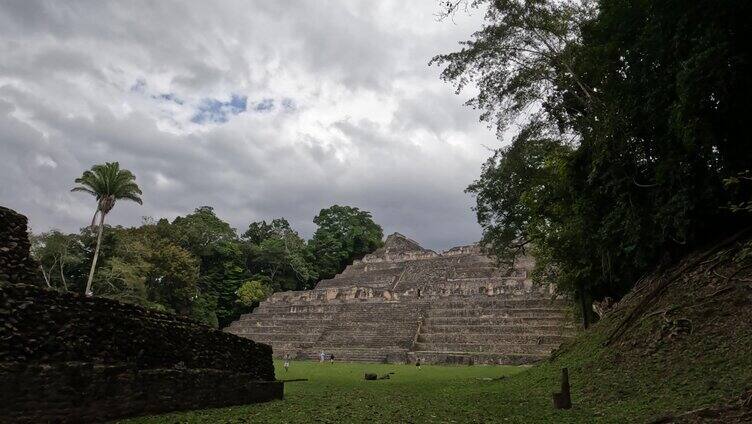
[0,284,274,380]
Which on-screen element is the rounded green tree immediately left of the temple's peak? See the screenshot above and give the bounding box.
[309,205,384,279]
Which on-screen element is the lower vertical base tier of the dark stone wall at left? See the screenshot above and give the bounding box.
[0,362,283,424]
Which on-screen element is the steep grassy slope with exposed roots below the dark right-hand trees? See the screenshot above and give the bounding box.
[515,234,752,422]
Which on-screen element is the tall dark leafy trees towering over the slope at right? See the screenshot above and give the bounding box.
[433,0,752,308]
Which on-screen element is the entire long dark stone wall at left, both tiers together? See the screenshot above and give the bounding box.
[0,283,282,422]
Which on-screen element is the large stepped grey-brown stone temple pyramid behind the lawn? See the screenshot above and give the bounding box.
[225,233,574,364]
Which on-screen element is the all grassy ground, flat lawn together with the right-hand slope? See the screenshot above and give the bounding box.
[119,237,752,423]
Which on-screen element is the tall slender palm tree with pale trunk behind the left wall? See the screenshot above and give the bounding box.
[71,162,143,296]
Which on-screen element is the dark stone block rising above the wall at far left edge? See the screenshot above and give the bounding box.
[0,206,38,283]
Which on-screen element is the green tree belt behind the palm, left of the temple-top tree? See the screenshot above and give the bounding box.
[32,206,382,328]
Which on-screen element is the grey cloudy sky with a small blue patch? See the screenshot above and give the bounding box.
[0,0,499,249]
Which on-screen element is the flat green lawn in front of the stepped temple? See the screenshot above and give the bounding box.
[116,361,579,423]
